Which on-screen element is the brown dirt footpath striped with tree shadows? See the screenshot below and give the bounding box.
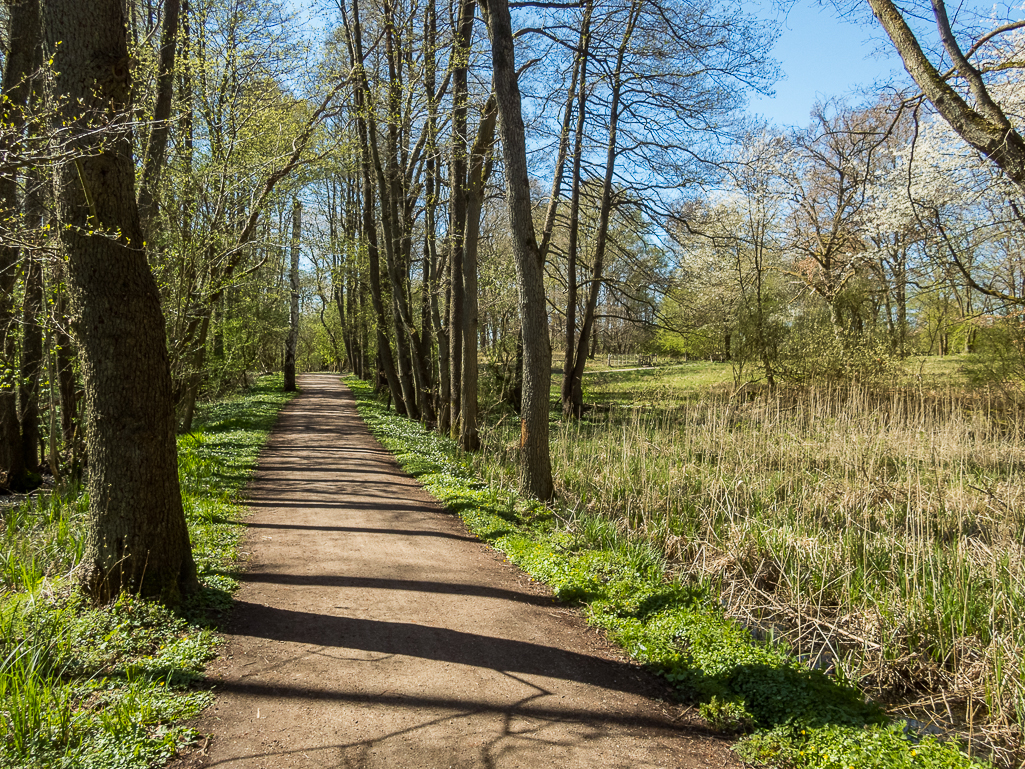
[174,374,738,769]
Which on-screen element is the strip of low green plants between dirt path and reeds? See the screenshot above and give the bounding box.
[345,377,986,769]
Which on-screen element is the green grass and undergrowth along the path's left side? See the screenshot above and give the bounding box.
[0,376,287,769]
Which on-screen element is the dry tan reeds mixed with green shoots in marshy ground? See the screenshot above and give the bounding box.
[483,386,1025,766]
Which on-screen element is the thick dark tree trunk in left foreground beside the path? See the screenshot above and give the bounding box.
[42,0,199,604]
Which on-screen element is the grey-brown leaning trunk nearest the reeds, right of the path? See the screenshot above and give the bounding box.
[486,0,555,499]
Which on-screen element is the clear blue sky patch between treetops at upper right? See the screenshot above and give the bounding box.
[745,0,906,126]
